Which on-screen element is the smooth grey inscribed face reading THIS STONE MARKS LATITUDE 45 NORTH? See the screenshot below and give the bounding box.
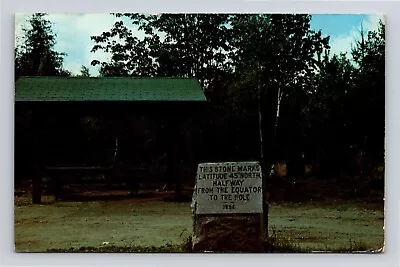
[194,162,263,214]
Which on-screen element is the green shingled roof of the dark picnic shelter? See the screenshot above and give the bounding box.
[15,76,206,101]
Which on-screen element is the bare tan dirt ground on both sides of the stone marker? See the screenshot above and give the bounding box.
[14,186,384,252]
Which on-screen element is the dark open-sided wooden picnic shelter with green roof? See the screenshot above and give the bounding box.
[15,77,206,203]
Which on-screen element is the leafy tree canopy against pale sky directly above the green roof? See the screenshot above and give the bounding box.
[91,13,230,88]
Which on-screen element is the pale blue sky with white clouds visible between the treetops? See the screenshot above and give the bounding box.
[15,13,383,76]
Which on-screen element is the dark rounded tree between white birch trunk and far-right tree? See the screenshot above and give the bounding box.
[302,51,355,177]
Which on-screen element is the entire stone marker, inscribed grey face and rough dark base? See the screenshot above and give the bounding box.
[191,162,264,252]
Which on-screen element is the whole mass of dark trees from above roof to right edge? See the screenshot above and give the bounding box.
[87,13,385,176]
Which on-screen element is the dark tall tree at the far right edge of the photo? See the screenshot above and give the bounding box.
[349,21,385,170]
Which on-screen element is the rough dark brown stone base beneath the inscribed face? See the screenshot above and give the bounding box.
[192,214,264,252]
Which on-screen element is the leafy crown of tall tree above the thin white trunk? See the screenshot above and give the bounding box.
[231,14,329,88]
